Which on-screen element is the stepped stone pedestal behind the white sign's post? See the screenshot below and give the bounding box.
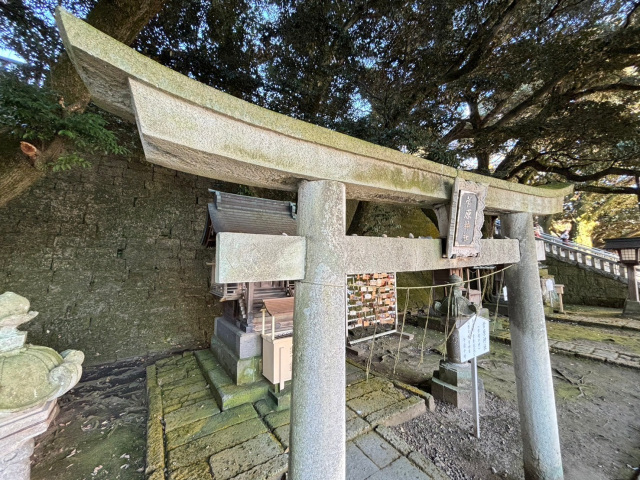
[431,360,485,411]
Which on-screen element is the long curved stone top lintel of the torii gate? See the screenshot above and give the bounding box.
[56,8,572,215]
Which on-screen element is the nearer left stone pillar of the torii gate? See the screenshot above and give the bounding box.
[289,181,346,480]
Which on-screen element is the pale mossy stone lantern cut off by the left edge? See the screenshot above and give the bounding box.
[0,292,84,480]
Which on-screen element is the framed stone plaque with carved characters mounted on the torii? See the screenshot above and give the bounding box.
[447,178,488,258]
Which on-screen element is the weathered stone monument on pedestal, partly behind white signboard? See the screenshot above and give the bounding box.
[431,275,487,410]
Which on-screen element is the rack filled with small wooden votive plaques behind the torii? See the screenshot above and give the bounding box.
[347,273,397,329]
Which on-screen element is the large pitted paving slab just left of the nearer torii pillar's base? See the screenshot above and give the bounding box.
[209,433,283,480]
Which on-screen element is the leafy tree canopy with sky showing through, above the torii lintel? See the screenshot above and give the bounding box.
[0,0,640,216]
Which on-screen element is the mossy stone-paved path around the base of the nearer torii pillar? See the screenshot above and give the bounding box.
[146,350,448,480]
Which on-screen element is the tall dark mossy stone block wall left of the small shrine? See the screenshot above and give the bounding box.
[0,157,225,364]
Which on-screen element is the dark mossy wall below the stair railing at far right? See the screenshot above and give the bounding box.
[544,254,628,308]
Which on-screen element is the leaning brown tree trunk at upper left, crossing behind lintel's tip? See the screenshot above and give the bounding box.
[0,0,167,207]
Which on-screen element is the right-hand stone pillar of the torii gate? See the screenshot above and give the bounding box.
[503,213,564,480]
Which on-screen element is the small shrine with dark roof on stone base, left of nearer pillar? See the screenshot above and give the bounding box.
[202,190,296,402]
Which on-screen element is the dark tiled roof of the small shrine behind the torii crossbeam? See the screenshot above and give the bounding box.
[201,190,296,247]
